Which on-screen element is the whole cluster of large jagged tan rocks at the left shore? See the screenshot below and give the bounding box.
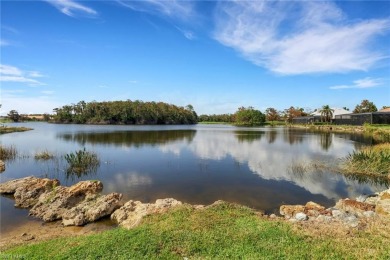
[0,177,122,226]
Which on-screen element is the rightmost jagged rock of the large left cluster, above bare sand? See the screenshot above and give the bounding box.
[62,193,122,226]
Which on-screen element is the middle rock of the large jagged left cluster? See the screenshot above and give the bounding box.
[30,181,103,221]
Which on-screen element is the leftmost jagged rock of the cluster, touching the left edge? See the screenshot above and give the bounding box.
[0,177,60,208]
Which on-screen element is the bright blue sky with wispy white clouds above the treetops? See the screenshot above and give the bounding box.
[0,0,390,115]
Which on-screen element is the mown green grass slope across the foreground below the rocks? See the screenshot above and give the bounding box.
[0,203,390,259]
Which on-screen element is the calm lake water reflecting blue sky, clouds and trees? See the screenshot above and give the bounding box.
[0,123,385,232]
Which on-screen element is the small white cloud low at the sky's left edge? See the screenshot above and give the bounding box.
[0,64,45,86]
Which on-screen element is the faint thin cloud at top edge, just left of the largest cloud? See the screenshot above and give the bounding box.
[117,0,195,20]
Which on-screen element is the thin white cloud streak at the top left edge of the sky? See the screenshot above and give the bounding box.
[45,0,98,17]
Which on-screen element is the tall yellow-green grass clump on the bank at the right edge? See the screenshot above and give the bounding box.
[342,143,390,178]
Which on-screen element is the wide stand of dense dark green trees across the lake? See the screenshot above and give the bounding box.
[53,100,198,125]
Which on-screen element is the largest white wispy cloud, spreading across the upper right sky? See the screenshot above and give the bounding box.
[215,1,390,74]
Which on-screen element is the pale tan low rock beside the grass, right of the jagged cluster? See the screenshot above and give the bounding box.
[111,198,182,229]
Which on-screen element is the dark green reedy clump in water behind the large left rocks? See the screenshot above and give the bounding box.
[65,148,100,175]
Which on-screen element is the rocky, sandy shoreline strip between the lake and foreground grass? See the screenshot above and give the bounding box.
[0,177,390,251]
